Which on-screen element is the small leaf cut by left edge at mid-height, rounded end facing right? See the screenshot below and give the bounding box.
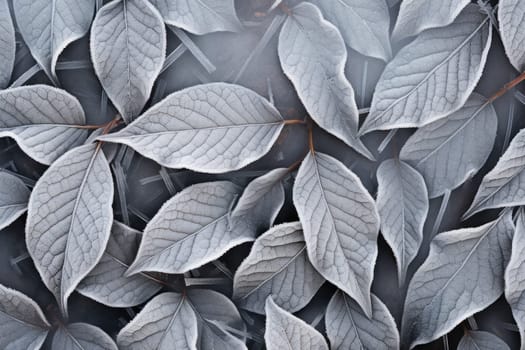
[0,172,31,230]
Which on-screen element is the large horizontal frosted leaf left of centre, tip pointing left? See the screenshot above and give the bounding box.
[100,83,285,173]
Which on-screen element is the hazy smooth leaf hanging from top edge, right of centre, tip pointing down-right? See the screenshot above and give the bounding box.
[310,0,392,62]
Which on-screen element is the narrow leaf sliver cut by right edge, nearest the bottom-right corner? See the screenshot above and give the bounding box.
[505,210,525,350]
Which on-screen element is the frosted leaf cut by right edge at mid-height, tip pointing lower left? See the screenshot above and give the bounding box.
[463,129,525,218]
